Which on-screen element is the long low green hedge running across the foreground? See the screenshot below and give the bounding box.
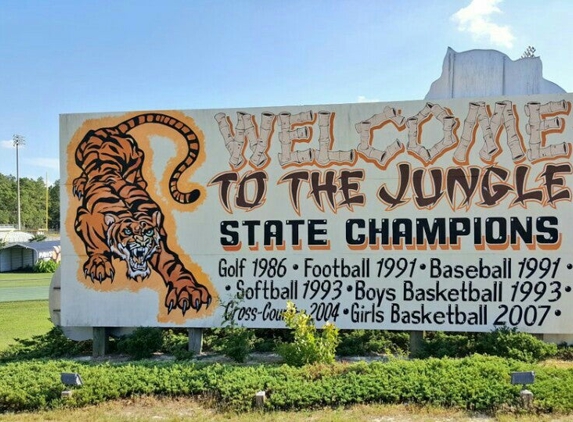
[0,355,573,413]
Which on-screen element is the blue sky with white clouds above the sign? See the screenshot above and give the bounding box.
[0,0,573,183]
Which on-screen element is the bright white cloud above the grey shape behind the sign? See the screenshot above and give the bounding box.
[451,0,515,48]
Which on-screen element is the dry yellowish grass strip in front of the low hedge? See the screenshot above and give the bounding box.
[0,397,571,422]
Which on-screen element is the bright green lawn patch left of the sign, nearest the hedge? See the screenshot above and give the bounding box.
[0,300,53,350]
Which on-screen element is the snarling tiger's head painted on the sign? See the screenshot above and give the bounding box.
[105,211,161,280]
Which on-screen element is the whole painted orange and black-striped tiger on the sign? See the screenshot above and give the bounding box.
[72,113,212,315]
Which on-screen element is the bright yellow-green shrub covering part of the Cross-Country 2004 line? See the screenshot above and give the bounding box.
[277,301,339,366]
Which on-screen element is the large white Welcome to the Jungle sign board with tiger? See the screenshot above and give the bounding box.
[61,94,573,333]
